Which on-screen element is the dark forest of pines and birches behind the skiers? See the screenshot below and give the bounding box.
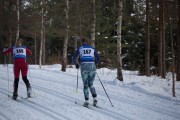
[0,0,180,80]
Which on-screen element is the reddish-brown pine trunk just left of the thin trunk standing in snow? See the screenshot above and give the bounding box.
[158,0,166,78]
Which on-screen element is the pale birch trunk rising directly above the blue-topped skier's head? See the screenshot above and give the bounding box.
[91,0,96,47]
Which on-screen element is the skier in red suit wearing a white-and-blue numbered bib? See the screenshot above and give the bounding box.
[3,39,32,100]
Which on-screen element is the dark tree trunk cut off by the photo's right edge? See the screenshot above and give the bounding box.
[176,0,180,81]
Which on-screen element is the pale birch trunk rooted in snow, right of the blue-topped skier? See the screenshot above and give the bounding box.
[117,0,123,81]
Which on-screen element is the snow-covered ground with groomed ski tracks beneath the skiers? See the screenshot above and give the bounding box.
[0,64,180,120]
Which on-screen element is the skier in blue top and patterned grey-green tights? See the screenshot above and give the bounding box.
[72,38,100,107]
